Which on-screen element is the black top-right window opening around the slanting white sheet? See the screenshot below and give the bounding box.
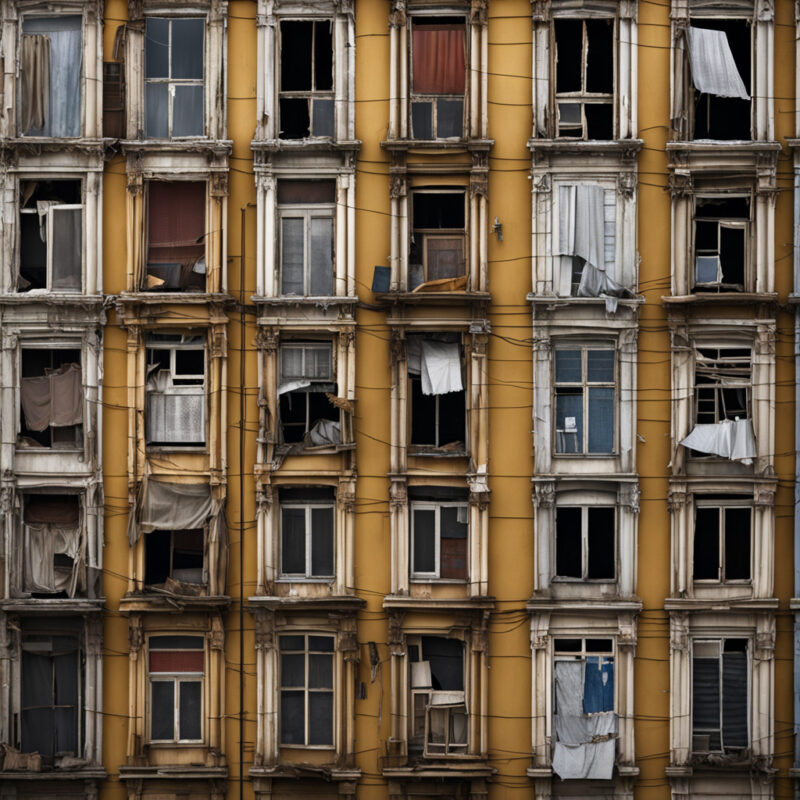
[691,17,752,141]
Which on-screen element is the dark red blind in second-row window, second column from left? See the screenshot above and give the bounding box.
[147,181,206,264]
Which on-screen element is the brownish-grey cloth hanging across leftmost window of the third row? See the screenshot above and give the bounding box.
[20,364,83,431]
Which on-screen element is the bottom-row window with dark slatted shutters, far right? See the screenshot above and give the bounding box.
[692,639,749,753]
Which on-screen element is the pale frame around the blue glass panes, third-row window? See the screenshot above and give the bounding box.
[550,340,620,458]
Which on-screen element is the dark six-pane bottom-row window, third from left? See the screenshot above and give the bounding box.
[278,633,334,747]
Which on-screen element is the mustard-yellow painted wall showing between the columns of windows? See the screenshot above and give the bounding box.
[102,0,794,800]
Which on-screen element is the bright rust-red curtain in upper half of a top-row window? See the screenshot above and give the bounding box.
[412,24,466,94]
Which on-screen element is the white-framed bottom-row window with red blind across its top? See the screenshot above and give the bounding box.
[149,636,205,743]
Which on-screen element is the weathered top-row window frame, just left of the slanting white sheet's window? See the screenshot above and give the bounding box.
[550,14,619,141]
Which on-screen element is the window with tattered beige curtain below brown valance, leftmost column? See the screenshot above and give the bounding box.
[22,494,86,597]
